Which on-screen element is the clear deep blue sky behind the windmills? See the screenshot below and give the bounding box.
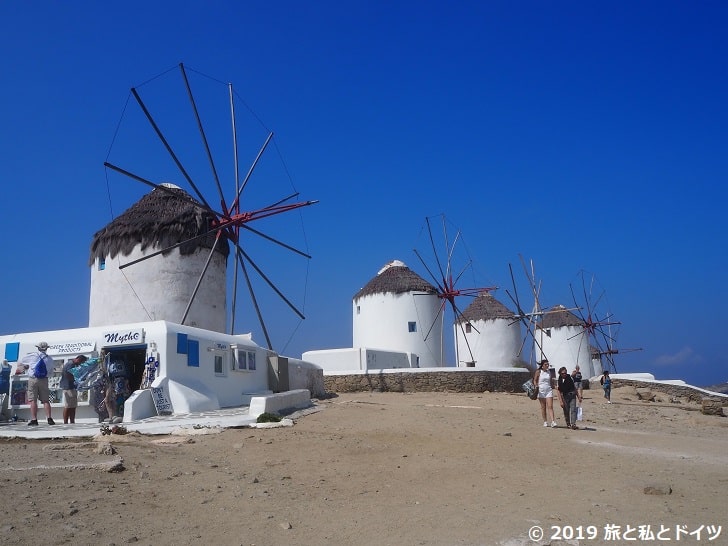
[0,1,728,385]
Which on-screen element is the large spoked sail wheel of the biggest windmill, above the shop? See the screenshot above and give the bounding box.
[99,64,317,349]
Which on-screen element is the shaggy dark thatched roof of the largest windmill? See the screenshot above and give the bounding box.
[89,185,230,265]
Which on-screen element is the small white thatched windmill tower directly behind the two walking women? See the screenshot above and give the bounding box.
[534,305,596,377]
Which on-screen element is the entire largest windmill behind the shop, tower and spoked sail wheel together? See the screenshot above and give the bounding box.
[95,64,317,350]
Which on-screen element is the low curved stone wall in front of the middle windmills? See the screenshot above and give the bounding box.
[324,368,531,393]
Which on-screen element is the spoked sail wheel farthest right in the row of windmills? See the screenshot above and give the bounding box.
[569,269,642,373]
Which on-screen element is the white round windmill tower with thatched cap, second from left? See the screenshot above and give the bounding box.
[352,260,442,368]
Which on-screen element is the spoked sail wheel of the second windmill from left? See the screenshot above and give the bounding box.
[414,214,496,366]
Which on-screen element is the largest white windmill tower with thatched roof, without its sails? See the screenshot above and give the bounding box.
[89,184,229,332]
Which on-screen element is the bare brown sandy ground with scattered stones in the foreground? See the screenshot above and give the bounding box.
[0,387,728,546]
